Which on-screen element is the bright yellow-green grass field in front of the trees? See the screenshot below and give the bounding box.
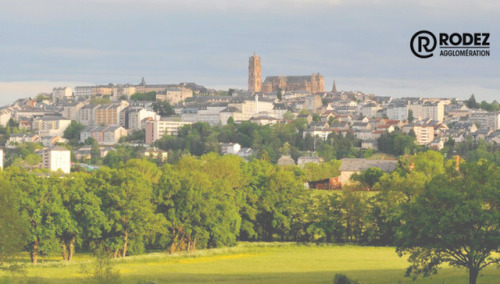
[0,243,500,283]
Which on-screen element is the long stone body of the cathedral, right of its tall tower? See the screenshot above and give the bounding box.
[262,73,325,94]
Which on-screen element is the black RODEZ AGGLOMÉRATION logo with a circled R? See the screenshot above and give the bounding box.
[410,30,490,58]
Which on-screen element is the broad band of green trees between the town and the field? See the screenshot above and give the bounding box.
[0,151,500,284]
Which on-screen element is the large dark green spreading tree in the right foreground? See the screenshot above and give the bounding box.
[396,160,500,284]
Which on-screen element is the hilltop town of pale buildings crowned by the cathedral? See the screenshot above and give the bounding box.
[0,54,500,182]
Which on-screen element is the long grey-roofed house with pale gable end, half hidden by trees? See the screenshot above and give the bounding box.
[339,158,398,186]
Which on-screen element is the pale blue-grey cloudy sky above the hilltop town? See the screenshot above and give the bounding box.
[0,0,500,105]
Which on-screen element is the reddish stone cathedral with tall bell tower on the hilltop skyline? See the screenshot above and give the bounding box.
[248,53,325,93]
